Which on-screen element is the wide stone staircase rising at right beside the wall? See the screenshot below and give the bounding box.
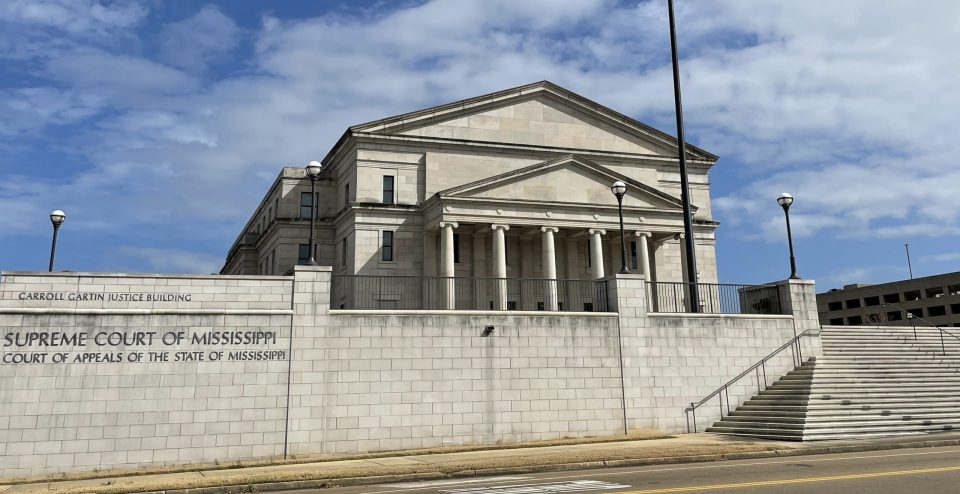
[707,326,960,441]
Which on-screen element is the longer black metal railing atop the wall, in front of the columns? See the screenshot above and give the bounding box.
[331,275,608,312]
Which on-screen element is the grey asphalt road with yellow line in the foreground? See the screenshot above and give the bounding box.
[296,447,960,494]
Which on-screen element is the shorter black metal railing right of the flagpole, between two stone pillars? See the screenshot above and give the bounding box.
[647,281,783,314]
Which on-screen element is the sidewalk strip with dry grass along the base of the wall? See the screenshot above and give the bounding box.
[0,432,960,494]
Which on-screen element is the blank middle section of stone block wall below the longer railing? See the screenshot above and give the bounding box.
[290,311,623,453]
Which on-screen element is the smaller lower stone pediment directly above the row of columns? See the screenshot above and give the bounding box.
[438,155,682,210]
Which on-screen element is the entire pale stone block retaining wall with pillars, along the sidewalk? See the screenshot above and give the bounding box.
[0,266,817,477]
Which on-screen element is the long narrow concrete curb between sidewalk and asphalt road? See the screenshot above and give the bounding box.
[137,439,960,494]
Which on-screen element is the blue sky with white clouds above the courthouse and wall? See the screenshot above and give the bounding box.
[0,0,960,290]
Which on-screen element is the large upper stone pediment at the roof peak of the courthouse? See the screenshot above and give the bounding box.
[350,81,717,161]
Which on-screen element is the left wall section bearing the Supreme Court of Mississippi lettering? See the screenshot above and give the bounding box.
[0,273,293,477]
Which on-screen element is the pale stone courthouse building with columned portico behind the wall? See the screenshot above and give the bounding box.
[221,81,718,310]
